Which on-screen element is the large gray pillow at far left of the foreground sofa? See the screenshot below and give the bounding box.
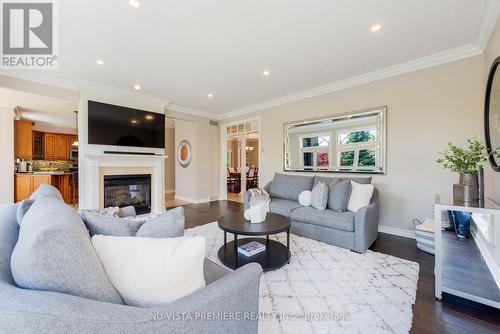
[10,196,123,304]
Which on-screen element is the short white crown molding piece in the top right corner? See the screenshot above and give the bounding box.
[472,0,500,50]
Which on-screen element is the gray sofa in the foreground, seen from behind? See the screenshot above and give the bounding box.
[0,204,262,334]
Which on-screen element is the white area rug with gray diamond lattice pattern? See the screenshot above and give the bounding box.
[186,223,419,334]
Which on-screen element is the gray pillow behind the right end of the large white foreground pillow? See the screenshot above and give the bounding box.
[136,208,184,238]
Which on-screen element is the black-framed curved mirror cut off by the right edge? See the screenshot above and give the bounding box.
[484,57,500,172]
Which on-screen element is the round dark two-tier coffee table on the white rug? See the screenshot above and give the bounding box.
[218,212,290,271]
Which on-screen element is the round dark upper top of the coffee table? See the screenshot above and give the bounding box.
[218,212,290,235]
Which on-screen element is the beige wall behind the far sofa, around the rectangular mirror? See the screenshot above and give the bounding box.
[224,56,485,230]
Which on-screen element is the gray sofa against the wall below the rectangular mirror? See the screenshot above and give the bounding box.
[244,173,379,253]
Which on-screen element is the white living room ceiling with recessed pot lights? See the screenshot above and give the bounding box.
[2,0,496,114]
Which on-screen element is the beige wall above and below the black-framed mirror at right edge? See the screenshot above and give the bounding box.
[483,21,500,203]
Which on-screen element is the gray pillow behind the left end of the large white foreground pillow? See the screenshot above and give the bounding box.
[80,210,144,237]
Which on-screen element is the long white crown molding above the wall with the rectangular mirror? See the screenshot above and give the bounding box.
[219,44,483,119]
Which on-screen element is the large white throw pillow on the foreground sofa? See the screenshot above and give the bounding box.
[92,235,205,307]
